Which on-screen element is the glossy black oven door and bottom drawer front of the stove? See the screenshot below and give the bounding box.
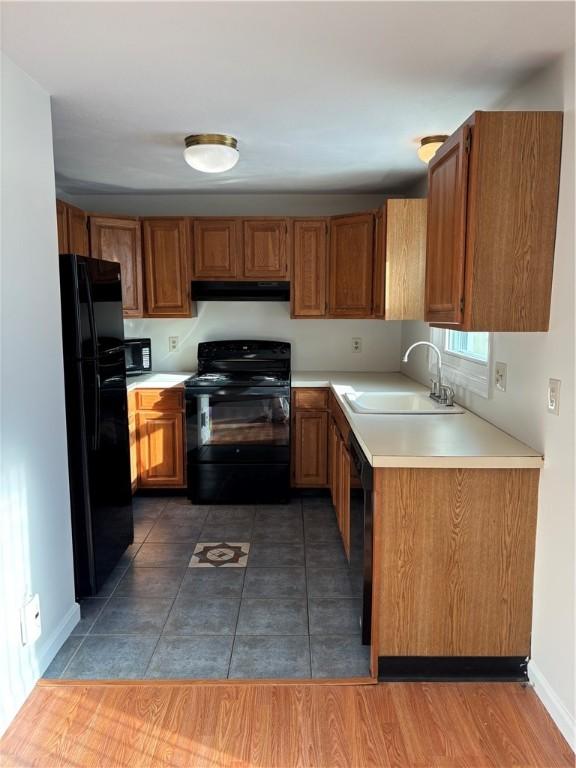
[186,387,290,504]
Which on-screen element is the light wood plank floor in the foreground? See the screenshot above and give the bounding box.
[0,683,574,768]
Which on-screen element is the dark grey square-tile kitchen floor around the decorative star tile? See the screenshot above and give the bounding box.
[45,497,369,679]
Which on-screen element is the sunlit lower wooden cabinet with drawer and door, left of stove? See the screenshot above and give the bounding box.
[128,389,186,490]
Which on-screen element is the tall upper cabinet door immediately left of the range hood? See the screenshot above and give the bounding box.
[143,219,192,317]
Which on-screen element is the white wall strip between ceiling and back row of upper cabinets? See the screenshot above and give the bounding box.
[58,191,386,216]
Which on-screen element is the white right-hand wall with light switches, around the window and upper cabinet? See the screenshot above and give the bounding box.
[402,54,576,746]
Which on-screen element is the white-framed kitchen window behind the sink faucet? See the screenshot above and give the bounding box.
[429,328,492,398]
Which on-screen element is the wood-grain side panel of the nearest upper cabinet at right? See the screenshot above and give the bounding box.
[465,112,562,331]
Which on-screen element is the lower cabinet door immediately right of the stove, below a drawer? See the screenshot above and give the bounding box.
[294,411,328,488]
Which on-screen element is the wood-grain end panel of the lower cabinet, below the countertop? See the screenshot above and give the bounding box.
[374,469,539,656]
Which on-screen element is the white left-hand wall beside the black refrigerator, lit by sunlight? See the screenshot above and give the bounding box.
[0,56,79,733]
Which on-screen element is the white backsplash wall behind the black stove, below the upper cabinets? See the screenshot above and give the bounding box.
[124,308,401,371]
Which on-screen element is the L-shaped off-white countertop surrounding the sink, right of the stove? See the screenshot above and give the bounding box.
[292,371,544,469]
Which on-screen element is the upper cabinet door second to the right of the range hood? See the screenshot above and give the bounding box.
[328,213,374,318]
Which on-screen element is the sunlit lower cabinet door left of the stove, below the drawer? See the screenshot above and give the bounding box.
[137,411,184,488]
